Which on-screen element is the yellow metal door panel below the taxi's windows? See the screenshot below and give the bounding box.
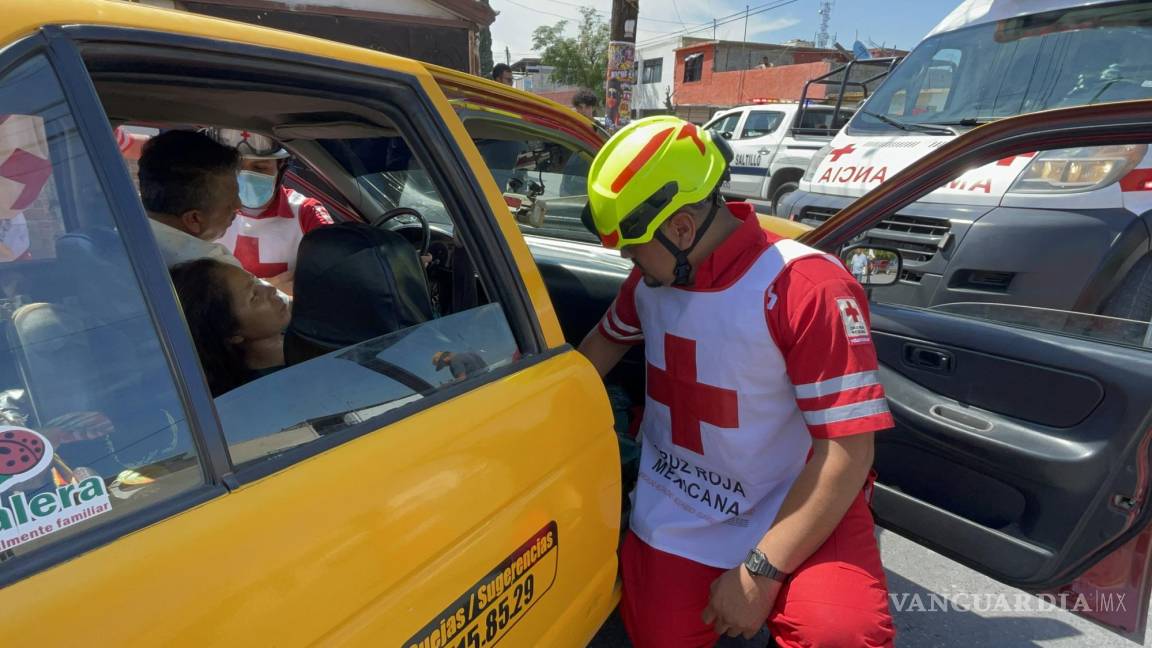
[0,352,620,648]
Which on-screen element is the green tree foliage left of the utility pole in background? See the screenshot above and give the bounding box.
[532,7,609,103]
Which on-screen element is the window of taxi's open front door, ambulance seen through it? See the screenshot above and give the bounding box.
[856,138,1152,349]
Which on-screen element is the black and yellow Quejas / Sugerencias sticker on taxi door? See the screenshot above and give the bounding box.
[404,521,560,648]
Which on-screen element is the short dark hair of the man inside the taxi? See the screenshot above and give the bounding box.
[139,130,240,216]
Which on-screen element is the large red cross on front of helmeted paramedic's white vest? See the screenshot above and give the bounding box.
[647,333,740,454]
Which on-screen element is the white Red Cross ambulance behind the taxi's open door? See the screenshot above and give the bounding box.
[778,0,1152,322]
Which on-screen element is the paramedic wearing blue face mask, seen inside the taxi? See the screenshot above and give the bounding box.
[214,128,333,294]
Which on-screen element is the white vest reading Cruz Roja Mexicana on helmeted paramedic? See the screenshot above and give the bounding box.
[631,240,839,568]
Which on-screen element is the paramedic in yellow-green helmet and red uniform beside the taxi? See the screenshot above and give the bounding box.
[581,116,894,648]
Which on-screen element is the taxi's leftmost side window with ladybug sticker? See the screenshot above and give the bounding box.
[0,56,203,569]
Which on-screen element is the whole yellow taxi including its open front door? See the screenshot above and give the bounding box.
[0,0,1152,648]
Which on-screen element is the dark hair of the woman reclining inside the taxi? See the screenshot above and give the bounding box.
[172,258,252,397]
